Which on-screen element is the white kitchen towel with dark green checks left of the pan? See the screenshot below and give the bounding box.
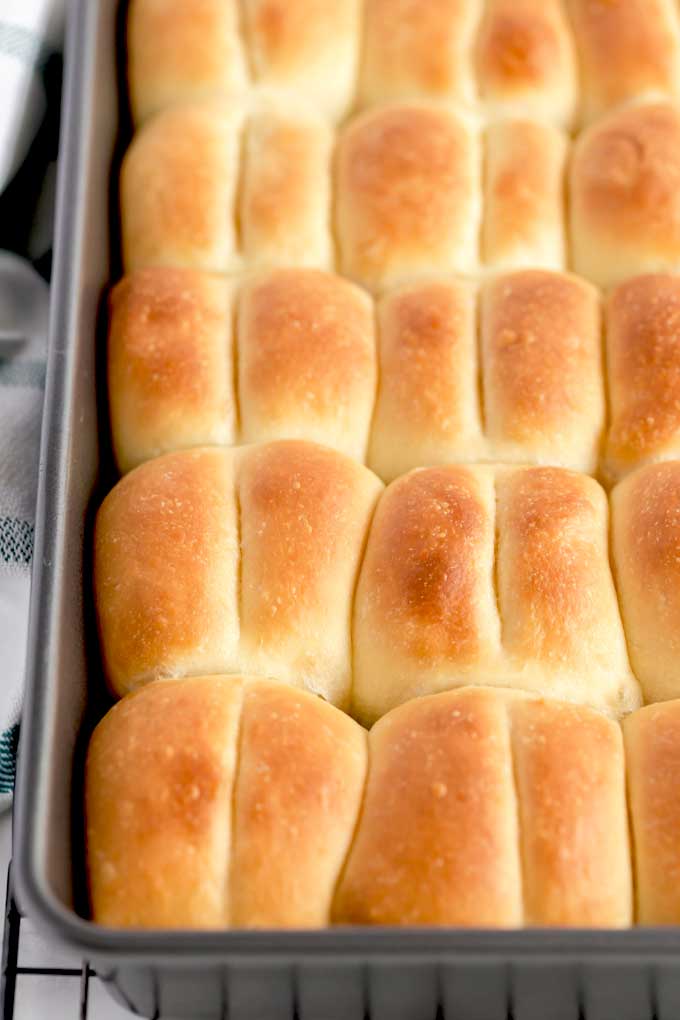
[0,0,65,810]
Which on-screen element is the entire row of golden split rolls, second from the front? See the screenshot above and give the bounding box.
[95,441,680,722]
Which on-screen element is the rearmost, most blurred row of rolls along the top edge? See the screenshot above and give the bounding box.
[127,0,680,125]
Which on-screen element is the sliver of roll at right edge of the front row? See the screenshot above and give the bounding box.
[623,701,680,924]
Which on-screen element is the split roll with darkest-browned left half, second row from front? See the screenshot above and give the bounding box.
[353,466,640,722]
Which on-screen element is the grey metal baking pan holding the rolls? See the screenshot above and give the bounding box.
[14,0,680,1020]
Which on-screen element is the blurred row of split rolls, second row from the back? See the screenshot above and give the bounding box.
[120,102,680,291]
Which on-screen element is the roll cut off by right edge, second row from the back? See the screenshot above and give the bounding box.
[570,103,680,287]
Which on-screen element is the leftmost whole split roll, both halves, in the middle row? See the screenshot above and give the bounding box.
[108,266,376,471]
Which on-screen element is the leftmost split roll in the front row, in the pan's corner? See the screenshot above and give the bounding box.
[86,676,373,928]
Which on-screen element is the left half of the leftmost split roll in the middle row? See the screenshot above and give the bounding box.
[108,266,237,471]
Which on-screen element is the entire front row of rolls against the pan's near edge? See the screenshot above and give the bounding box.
[86,676,680,928]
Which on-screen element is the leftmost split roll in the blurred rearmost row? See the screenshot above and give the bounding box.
[127,0,360,122]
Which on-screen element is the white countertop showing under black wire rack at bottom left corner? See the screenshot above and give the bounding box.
[0,812,132,1020]
